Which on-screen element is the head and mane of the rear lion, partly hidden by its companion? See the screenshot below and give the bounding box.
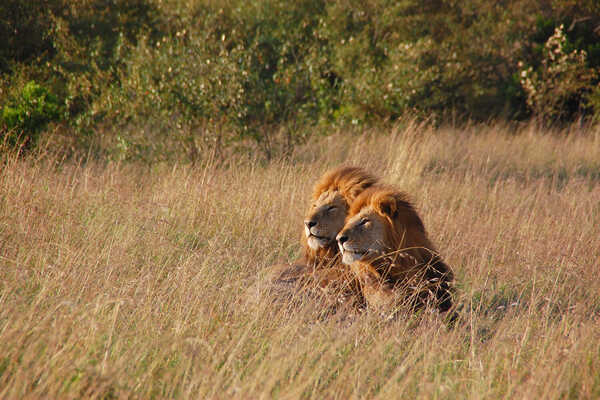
[303,167,377,261]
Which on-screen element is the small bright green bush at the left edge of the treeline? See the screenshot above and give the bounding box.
[2,81,62,148]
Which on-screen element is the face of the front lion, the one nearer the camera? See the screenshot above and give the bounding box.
[337,207,389,265]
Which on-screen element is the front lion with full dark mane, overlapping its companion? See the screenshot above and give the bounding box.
[337,185,454,312]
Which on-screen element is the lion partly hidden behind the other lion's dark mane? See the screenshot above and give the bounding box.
[269,166,378,306]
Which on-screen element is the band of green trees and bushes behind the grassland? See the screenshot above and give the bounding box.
[0,0,600,161]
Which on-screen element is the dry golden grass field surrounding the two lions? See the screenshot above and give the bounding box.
[0,125,600,399]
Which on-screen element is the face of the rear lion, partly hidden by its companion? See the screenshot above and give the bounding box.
[304,191,348,250]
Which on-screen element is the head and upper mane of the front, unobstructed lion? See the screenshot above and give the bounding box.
[337,186,433,265]
